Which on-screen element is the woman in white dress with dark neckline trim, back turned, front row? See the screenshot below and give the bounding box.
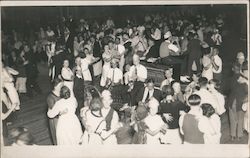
[82,98,106,145]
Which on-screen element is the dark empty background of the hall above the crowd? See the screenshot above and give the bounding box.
[1,4,247,35]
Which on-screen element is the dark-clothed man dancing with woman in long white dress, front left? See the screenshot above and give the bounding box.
[47,78,63,145]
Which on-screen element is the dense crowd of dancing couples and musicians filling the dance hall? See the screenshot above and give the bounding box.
[2,7,248,145]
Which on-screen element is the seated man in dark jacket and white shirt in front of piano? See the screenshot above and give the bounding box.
[135,79,162,104]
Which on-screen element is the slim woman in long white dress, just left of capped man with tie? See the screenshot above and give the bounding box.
[100,45,112,87]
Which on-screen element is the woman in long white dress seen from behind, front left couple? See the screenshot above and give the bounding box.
[47,86,83,145]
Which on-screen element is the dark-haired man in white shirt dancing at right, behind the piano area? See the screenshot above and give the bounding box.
[211,48,222,81]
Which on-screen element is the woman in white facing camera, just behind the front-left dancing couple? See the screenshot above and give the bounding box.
[61,60,74,97]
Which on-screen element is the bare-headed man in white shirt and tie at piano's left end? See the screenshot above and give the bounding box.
[129,54,148,82]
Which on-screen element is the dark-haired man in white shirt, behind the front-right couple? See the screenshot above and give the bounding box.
[194,77,220,114]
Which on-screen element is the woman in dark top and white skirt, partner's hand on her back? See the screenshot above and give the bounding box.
[159,85,189,144]
